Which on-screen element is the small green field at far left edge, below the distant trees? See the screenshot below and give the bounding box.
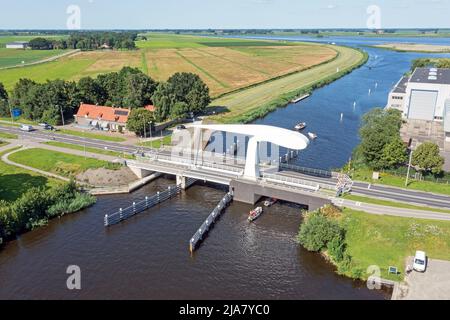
[0,48,69,68]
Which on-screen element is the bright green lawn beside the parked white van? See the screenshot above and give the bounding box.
[341,209,450,280]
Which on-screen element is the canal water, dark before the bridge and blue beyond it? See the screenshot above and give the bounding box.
[0,35,448,299]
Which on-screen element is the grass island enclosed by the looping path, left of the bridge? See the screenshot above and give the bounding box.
[9,148,120,177]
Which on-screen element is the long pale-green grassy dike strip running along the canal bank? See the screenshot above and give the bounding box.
[212,46,367,123]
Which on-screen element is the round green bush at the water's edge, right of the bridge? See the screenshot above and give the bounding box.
[298,212,343,252]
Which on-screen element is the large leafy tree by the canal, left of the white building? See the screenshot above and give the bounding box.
[359,108,402,169]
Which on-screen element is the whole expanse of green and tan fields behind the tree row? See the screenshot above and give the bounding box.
[0,34,337,97]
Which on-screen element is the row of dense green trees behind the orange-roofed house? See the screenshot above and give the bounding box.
[0,67,210,132]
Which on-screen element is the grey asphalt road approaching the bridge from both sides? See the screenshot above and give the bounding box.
[0,124,450,209]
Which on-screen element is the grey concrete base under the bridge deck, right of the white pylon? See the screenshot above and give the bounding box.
[230,180,331,211]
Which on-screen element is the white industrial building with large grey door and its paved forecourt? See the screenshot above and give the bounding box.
[387,68,450,156]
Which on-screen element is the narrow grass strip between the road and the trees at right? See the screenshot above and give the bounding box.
[352,169,450,195]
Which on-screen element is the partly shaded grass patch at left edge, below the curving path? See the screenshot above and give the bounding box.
[0,147,59,201]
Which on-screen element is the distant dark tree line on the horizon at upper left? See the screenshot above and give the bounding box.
[28,32,138,51]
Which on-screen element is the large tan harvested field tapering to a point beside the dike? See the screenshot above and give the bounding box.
[145,45,337,96]
